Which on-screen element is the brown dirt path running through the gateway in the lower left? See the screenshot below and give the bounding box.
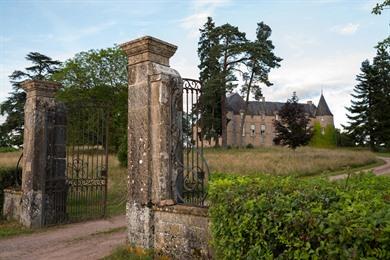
[0,216,126,260]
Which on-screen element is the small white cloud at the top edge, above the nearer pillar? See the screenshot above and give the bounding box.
[180,0,230,38]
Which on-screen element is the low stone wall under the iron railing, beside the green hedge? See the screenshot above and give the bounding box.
[153,205,212,259]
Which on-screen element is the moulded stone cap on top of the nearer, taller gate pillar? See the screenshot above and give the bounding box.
[119,36,177,66]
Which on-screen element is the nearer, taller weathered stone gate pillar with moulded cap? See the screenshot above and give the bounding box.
[121,36,182,248]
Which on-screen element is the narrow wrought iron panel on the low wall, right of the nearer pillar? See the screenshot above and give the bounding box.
[171,79,209,206]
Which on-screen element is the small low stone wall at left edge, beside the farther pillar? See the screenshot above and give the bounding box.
[3,189,22,221]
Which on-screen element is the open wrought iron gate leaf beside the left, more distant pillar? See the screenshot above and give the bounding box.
[66,105,109,221]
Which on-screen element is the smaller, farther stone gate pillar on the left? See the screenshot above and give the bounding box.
[20,80,60,227]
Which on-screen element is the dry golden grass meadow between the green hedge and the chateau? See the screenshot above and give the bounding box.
[205,147,377,176]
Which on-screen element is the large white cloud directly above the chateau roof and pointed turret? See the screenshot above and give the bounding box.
[263,52,373,127]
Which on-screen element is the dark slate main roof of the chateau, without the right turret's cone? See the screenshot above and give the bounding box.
[227,93,318,117]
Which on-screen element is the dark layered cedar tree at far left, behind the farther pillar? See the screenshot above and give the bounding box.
[0,52,61,146]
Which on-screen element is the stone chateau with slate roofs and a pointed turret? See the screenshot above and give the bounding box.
[210,93,334,146]
